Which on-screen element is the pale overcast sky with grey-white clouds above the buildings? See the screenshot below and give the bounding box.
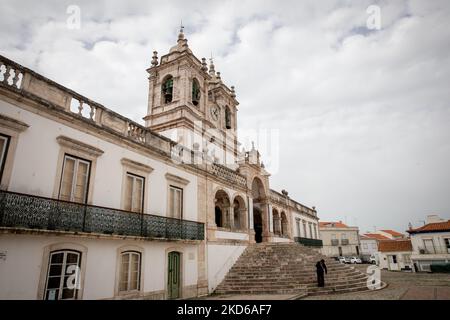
[0,0,450,231]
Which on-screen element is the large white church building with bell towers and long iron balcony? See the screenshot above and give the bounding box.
[0,32,321,300]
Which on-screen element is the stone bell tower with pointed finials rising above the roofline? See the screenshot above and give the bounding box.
[144,26,243,164]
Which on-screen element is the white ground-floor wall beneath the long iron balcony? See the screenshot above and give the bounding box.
[0,235,198,299]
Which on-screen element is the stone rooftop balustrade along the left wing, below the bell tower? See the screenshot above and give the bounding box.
[0,55,247,187]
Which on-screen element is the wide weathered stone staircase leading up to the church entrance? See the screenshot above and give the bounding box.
[214,243,374,296]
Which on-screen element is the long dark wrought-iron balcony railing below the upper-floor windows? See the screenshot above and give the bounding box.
[0,191,204,240]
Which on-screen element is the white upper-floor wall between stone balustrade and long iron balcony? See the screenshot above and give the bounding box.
[0,101,198,221]
